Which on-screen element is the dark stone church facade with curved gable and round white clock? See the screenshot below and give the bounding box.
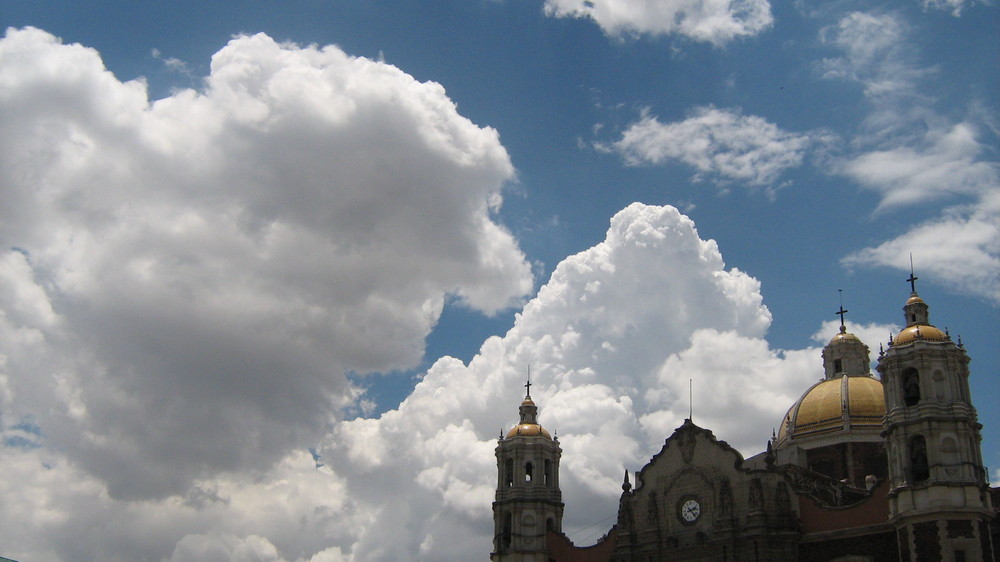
[611,420,798,562]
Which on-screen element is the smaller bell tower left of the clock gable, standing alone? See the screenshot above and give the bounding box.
[490,381,563,562]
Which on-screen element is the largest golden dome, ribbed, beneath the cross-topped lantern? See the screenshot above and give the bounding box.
[778,376,885,446]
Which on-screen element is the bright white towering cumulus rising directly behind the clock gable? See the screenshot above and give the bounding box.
[323,204,832,560]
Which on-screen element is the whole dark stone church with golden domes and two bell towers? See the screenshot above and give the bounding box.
[490,275,1000,562]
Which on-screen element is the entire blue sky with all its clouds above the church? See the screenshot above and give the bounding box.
[0,0,1000,562]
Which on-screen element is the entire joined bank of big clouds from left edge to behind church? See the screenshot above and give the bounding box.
[0,29,900,562]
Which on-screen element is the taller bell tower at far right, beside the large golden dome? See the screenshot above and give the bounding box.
[877,272,993,562]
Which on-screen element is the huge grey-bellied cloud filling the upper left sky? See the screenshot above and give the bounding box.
[0,25,532,498]
